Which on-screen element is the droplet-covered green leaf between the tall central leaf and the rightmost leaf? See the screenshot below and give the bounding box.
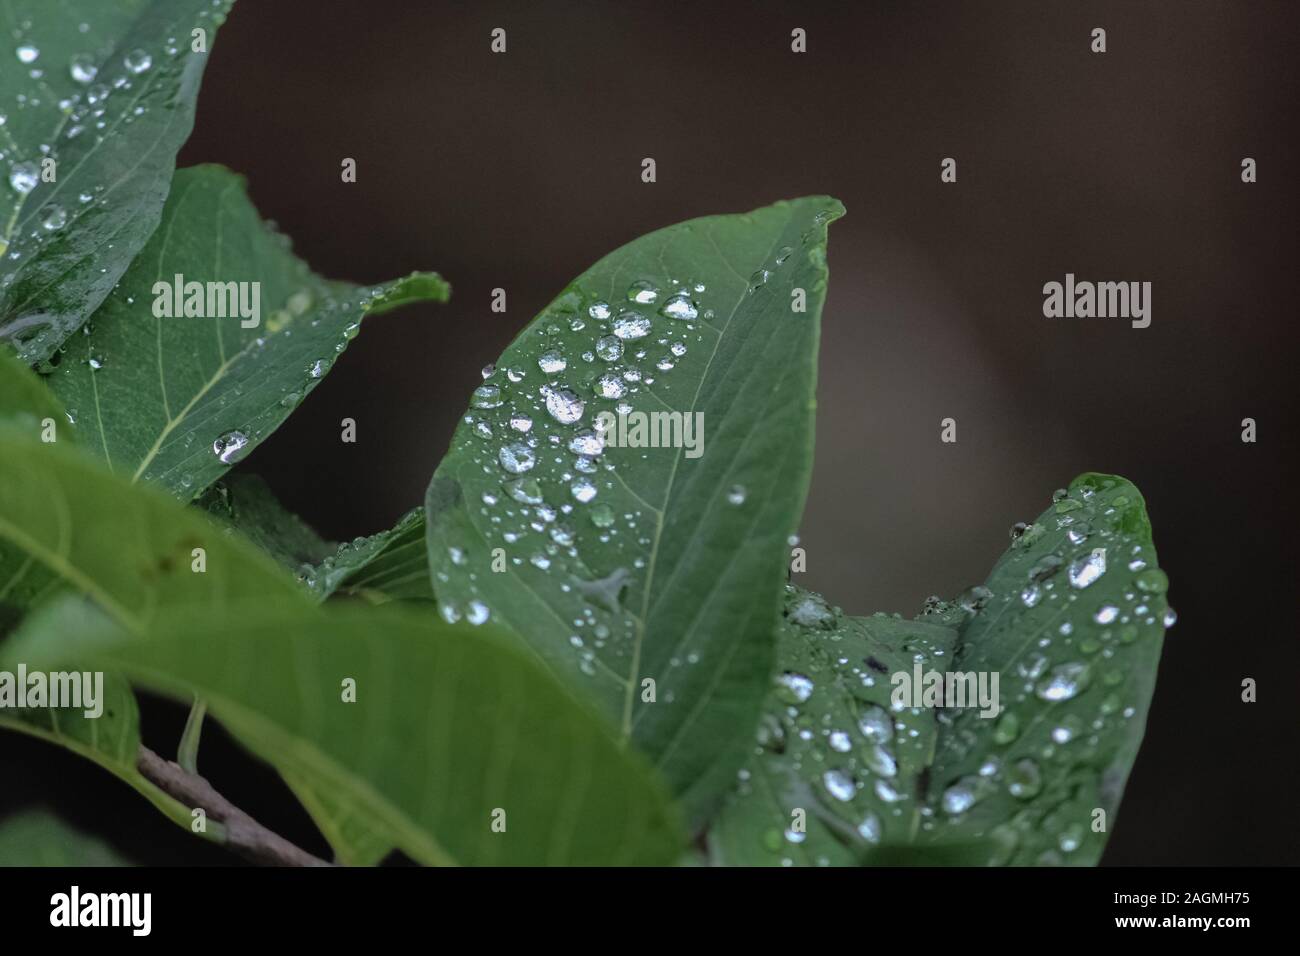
[709,587,957,866]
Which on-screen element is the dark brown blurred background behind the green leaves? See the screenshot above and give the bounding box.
[0,0,1300,864]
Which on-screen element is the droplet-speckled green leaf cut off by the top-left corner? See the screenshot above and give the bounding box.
[0,0,230,363]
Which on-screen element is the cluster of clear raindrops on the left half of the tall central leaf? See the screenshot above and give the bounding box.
[434,211,833,650]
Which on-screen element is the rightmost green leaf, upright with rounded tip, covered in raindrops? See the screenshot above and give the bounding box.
[931,473,1173,865]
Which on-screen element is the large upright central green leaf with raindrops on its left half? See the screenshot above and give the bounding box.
[426,196,842,821]
